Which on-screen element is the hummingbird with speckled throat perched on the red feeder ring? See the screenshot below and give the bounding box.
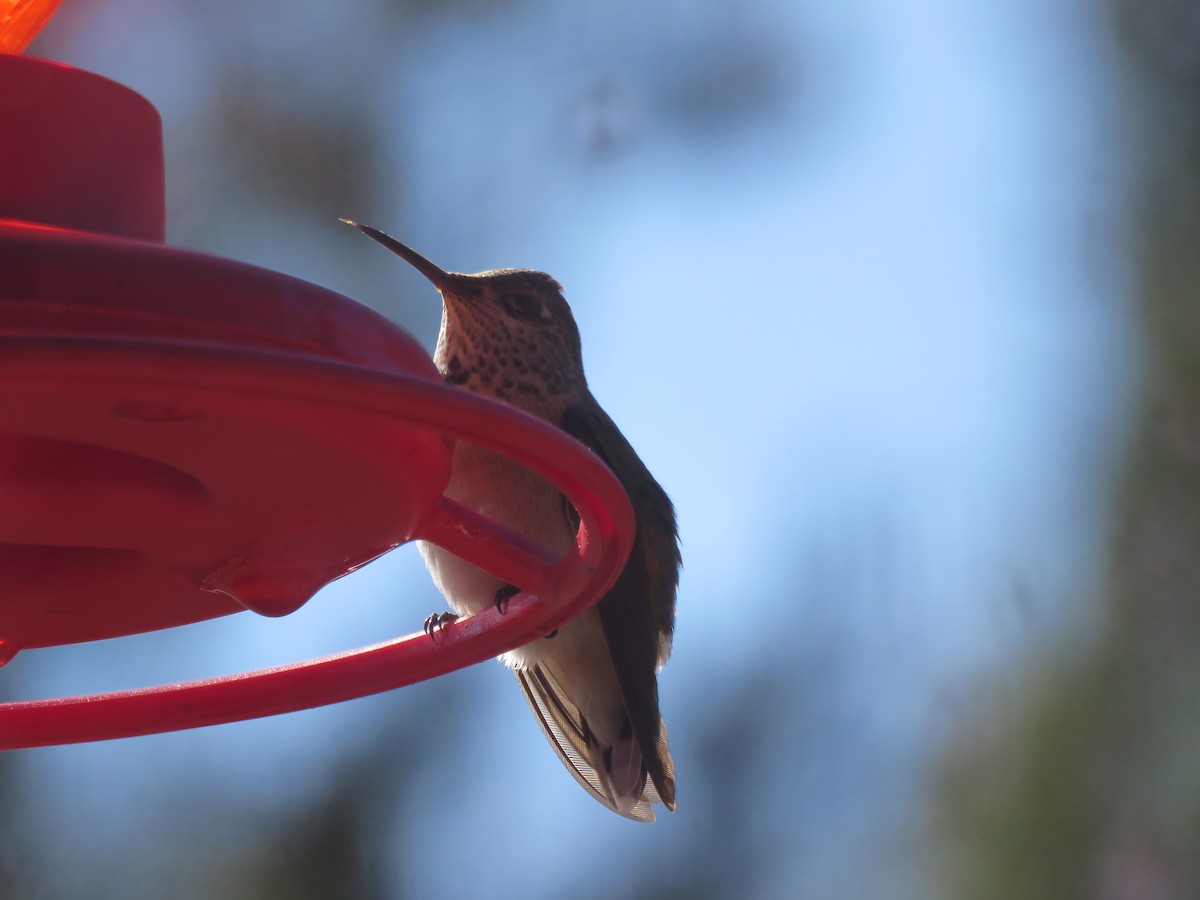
[342,220,680,822]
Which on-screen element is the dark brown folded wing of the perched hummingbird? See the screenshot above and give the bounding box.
[560,397,680,811]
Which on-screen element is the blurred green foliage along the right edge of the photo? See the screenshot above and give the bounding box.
[942,0,1200,900]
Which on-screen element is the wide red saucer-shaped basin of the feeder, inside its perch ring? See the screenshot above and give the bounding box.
[0,223,450,648]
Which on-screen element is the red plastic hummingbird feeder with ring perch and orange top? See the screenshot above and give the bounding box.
[0,8,635,749]
